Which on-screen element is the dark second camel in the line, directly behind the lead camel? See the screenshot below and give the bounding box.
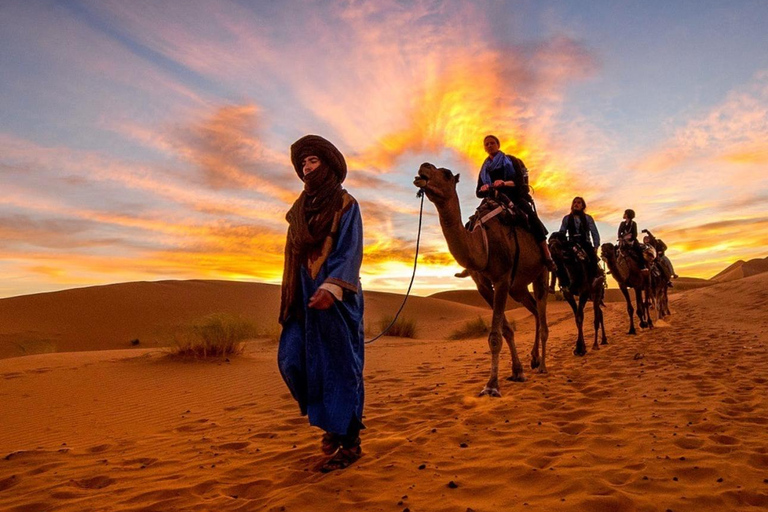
[549,232,608,356]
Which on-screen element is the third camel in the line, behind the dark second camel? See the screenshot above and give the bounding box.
[600,243,653,334]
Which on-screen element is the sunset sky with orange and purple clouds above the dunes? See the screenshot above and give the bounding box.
[0,0,768,297]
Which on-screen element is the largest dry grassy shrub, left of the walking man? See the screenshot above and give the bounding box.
[171,313,259,358]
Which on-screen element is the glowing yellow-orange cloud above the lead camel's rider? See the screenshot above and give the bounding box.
[350,39,595,212]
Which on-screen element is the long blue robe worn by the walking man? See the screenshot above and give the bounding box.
[277,196,365,435]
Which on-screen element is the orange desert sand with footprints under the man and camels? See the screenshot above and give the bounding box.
[0,273,768,512]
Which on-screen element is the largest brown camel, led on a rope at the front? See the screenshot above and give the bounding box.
[413,163,549,397]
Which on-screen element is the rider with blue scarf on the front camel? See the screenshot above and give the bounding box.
[475,135,557,272]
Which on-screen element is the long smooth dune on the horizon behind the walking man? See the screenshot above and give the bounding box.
[0,280,490,358]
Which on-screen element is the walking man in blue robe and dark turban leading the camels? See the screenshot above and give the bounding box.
[278,135,365,472]
